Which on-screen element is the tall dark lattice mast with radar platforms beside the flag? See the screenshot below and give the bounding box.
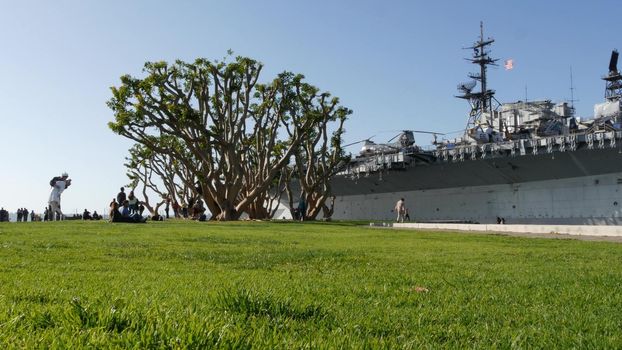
[456,22,501,132]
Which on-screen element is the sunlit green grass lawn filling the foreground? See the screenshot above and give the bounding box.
[0,221,622,348]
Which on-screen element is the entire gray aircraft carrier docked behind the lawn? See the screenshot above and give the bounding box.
[332,26,622,225]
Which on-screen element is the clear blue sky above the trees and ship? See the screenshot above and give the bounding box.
[0,0,622,213]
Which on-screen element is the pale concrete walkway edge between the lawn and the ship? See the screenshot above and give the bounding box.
[386,223,622,242]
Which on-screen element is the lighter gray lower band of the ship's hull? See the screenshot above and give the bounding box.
[333,173,622,225]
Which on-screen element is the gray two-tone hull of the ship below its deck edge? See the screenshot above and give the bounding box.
[333,147,622,225]
